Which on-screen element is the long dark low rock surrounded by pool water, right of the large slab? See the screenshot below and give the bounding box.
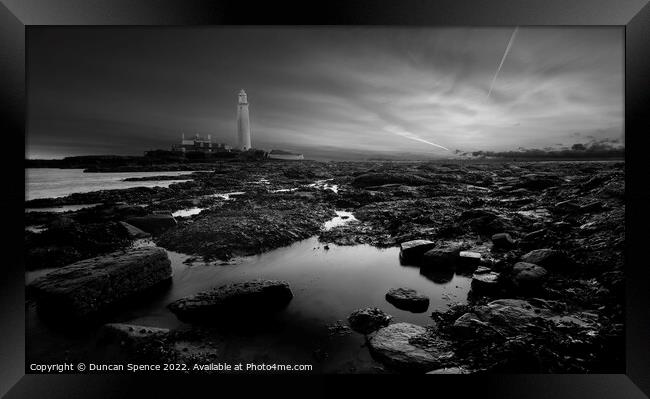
[168,280,293,322]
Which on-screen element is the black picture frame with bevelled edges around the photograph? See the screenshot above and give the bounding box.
[0,0,650,398]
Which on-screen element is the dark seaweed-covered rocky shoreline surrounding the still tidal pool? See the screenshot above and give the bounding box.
[25,162,625,373]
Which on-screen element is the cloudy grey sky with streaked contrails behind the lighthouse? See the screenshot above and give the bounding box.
[26,27,624,158]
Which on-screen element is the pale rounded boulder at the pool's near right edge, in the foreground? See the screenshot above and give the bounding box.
[368,323,454,372]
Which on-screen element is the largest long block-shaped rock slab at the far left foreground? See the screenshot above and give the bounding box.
[28,247,172,317]
